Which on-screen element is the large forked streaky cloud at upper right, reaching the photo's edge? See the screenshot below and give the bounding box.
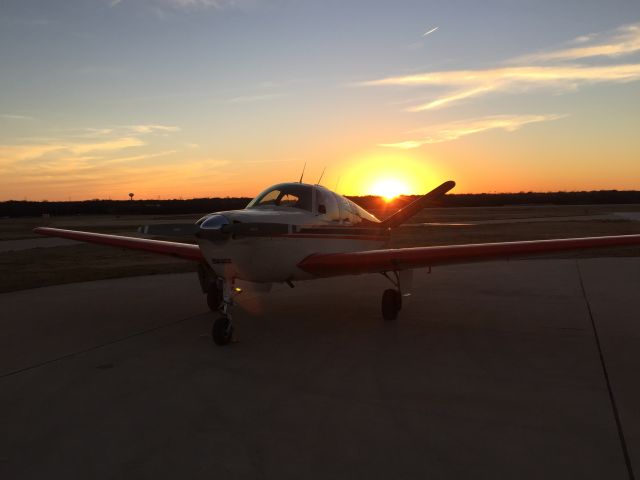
[359,24,640,112]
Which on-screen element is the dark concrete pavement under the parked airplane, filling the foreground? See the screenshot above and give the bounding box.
[0,258,640,479]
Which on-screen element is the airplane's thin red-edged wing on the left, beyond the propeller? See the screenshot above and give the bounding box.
[33,227,204,262]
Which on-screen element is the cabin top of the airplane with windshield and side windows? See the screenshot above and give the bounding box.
[247,183,379,225]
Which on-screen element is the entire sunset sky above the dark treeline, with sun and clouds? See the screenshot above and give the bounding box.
[0,0,640,200]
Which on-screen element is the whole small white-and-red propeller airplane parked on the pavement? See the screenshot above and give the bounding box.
[34,178,640,345]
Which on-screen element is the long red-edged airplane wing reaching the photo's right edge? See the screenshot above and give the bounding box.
[298,235,640,277]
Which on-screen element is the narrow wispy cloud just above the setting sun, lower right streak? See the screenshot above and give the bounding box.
[379,114,566,150]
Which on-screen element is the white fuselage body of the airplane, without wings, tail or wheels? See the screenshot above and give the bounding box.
[198,184,389,283]
